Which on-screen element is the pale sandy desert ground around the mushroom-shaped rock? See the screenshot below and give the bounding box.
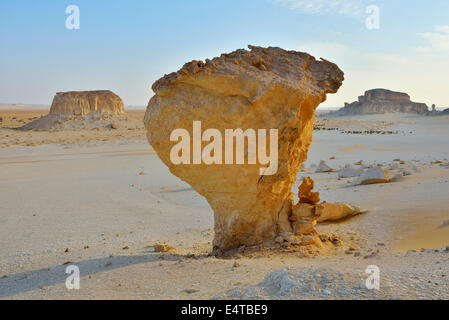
[0,112,449,299]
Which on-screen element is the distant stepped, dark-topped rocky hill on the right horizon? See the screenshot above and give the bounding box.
[326,89,429,116]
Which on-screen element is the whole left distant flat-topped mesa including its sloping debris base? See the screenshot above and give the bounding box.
[20,90,125,131]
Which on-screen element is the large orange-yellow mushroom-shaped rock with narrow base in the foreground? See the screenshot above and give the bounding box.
[144,46,344,250]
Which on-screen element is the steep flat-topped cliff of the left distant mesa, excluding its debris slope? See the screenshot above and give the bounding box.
[50,90,125,116]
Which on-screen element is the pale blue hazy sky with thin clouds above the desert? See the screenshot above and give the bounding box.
[0,0,449,107]
